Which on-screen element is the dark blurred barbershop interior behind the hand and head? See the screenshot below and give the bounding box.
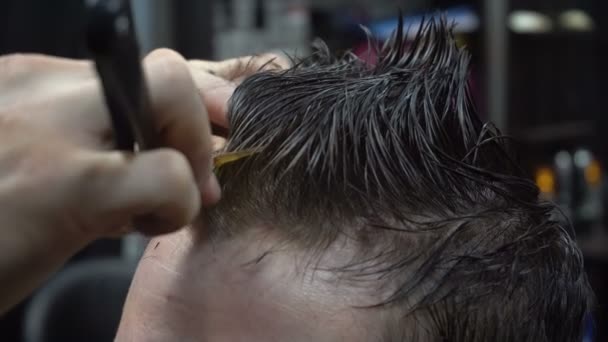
[0,0,608,342]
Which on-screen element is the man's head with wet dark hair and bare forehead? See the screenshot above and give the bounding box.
[119,21,590,341]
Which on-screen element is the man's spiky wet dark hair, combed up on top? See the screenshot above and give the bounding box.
[208,20,590,341]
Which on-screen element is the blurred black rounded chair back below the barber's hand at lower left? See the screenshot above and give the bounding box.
[24,258,135,342]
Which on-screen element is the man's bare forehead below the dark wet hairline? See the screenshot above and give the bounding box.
[119,229,382,341]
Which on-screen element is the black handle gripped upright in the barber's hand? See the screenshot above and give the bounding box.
[86,0,159,151]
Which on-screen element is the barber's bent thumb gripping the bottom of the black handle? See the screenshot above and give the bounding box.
[76,149,201,235]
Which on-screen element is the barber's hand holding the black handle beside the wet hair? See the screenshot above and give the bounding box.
[0,50,288,313]
